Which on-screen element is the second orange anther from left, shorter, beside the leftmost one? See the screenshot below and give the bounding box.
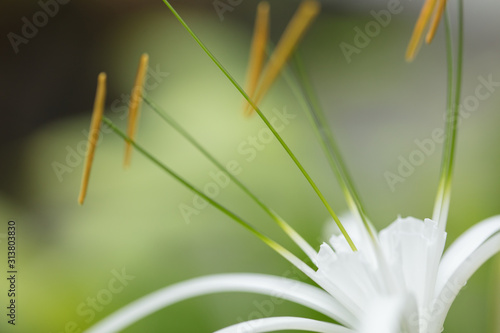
[123,53,149,168]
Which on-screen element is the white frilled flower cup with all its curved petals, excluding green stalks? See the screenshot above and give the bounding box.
[83,216,500,333]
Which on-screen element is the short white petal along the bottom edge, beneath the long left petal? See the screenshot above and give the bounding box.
[214,317,355,333]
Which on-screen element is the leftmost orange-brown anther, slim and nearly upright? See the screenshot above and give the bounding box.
[78,73,106,205]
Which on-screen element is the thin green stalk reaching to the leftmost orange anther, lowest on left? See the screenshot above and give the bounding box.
[102,117,311,275]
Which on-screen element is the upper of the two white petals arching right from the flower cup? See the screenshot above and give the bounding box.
[436,215,500,295]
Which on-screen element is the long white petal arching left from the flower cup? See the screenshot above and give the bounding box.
[86,274,356,333]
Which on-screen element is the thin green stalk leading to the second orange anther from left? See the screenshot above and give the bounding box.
[143,97,316,262]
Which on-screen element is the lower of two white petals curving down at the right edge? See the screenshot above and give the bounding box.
[428,233,500,332]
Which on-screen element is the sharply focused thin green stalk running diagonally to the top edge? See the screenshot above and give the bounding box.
[163,0,357,251]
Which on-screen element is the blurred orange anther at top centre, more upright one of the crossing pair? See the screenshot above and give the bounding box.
[243,1,270,115]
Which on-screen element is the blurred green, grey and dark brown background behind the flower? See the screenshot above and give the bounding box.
[0,0,500,333]
